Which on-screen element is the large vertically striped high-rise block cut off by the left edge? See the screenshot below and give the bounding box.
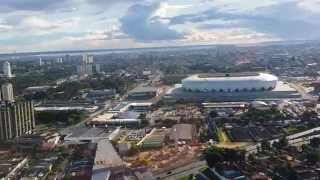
[0,101,35,141]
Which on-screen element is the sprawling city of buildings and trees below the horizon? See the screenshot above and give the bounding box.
[0,41,320,180]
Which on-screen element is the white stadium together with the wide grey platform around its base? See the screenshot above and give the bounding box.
[164,73,301,102]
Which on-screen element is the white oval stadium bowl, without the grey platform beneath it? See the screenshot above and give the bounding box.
[182,73,278,92]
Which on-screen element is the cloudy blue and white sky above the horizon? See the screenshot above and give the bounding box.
[0,0,320,53]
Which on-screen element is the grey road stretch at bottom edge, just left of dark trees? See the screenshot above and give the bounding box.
[156,161,207,180]
